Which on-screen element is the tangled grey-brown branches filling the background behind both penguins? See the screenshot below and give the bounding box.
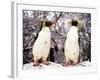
[23,10,91,64]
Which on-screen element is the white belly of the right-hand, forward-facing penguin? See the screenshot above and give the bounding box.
[64,26,79,62]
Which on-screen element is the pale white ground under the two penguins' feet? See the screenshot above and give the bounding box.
[23,61,91,70]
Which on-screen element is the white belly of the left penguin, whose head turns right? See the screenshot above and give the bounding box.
[32,27,51,60]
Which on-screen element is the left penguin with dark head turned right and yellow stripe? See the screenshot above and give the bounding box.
[32,19,52,66]
